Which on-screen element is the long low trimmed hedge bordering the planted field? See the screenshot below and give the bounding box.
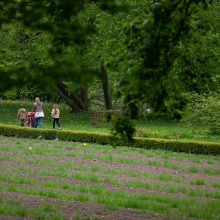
[0,125,220,155]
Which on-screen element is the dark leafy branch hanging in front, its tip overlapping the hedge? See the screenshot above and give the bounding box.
[112,0,216,140]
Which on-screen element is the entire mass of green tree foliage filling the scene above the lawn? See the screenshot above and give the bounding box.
[0,0,220,140]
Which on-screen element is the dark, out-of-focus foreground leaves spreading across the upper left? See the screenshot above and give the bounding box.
[0,0,122,88]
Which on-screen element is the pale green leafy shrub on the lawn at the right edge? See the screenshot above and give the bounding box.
[183,93,220,134]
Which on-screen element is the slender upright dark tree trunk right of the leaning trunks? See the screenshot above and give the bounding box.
[100,64,112,109]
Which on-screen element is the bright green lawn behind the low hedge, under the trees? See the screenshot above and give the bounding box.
[0,101,220,142]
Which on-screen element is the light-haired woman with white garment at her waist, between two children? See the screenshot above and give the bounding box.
[32,97,44,128]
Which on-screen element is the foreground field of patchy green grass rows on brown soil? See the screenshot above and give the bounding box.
[0,136,220,220]
